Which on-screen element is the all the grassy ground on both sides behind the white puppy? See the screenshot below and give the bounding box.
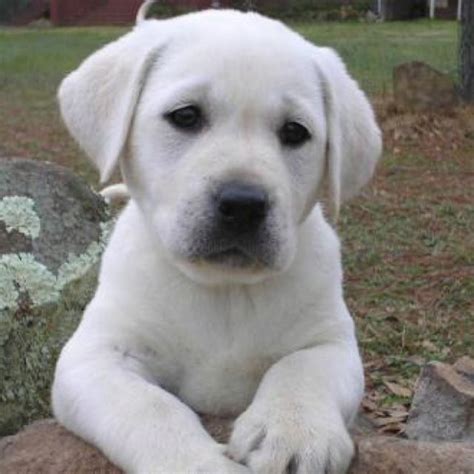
[0,21,474,426]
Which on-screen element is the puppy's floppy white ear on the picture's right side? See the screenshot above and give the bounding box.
[316,48,382,220]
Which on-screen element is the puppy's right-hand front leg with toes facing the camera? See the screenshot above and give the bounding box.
[228,341,364,474]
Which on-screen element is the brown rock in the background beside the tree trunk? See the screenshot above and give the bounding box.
[393,61,459,112]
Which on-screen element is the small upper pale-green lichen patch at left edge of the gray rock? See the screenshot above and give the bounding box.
[0,196,41,239]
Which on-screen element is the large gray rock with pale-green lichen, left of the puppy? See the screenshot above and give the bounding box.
[0,159,110,436]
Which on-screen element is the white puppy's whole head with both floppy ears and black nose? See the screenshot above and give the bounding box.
[59,11,381,283]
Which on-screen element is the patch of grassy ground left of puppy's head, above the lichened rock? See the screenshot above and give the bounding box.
[0,27,125,183]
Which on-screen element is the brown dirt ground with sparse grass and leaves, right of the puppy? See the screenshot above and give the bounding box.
[340,100,474,434]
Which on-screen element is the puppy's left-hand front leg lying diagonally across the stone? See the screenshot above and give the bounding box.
[53,320,248,474]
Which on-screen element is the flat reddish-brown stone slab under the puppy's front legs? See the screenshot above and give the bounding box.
[0,417,474,474]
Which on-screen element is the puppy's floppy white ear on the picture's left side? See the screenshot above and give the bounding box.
[58,22,165,183]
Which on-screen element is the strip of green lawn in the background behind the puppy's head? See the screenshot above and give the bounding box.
[0,21,458,94]
